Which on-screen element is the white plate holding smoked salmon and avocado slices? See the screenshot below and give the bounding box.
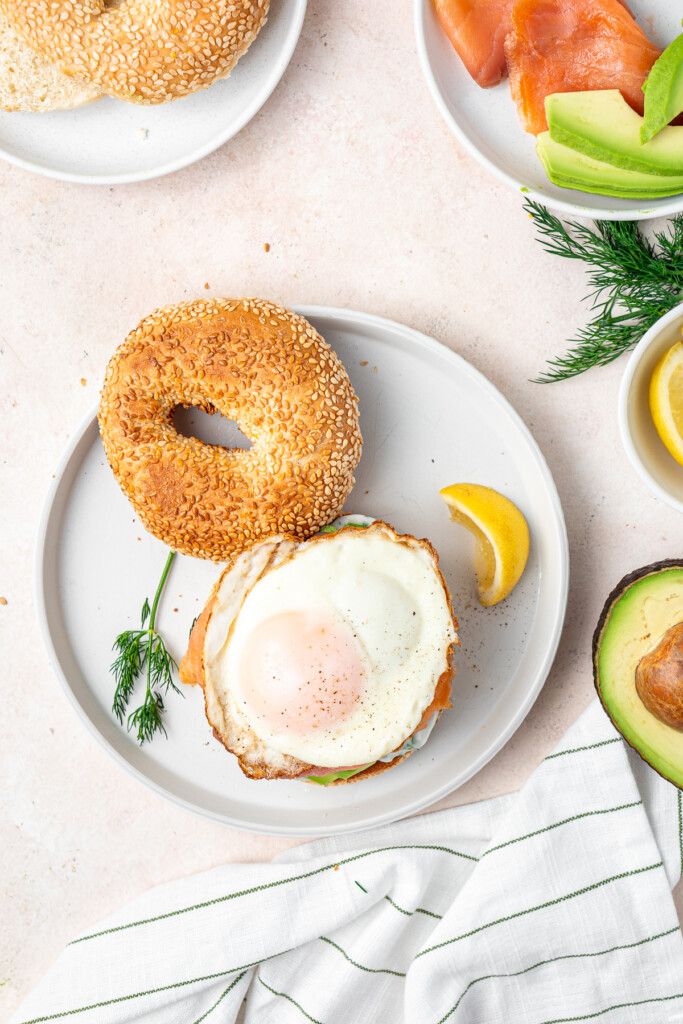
[414,0,683,220]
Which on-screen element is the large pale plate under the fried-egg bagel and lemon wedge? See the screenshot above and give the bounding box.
[36,307,568,836]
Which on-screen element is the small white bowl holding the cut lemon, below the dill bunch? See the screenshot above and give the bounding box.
[618,303,683,512]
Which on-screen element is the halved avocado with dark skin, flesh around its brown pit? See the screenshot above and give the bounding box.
[593,558,683,788]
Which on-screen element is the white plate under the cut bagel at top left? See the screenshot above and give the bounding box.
[0,0,306,185]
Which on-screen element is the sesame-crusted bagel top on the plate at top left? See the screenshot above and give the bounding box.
[0,0,268,103]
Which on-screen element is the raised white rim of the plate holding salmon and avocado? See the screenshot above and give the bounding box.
[413,0,683,220]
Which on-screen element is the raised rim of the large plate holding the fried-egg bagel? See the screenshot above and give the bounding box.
[33,304,569,839]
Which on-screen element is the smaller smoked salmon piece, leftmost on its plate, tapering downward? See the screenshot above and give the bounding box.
[434,0,515,89]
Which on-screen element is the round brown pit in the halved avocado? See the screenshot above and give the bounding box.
[636,623,683,732]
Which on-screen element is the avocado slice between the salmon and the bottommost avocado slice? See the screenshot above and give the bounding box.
[546,89,683,177]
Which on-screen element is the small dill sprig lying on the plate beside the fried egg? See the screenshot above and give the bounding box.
[112,551,180,744]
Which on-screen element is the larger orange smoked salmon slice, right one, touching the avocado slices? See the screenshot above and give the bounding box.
[505,0,661,135]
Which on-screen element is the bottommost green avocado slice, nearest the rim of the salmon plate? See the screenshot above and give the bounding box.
[536,131,683,199]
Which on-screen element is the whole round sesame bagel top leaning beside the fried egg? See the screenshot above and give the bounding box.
[99,299,362,561]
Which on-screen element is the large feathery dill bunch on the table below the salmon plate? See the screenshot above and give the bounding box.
[525,200,683,384]
